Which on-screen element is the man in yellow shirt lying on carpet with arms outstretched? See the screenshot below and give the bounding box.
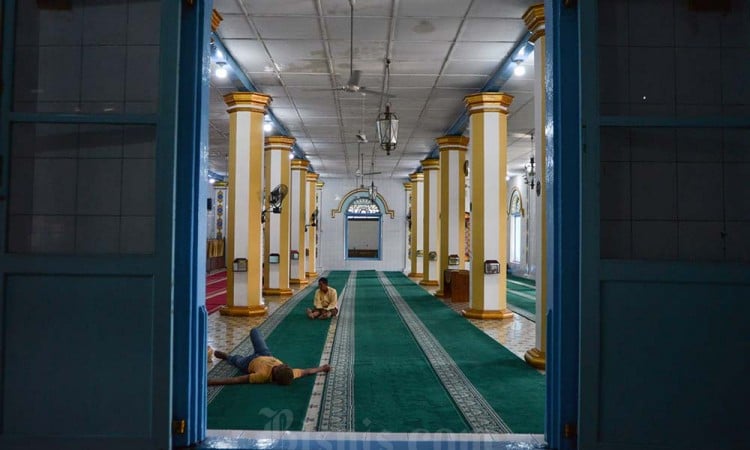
[208,328,331,386]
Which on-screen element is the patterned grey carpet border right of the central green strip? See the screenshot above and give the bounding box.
[378,272,512,433]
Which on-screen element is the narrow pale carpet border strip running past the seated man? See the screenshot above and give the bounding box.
[302,272,357,431]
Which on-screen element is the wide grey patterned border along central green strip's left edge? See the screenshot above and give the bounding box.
[317,272,357,431]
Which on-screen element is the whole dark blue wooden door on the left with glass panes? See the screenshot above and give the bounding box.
[0,0,181,449]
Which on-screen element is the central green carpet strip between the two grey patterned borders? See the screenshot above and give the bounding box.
[352,271,469,433]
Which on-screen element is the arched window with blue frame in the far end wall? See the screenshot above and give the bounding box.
[346,197,382,259]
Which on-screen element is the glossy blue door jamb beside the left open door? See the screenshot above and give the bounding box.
[172,0,213,447]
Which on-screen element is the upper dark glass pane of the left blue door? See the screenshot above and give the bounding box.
[13,0,160,114]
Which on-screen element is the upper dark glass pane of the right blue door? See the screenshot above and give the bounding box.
[598,0,750,117]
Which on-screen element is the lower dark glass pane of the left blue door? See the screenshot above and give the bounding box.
[7,123,156,254]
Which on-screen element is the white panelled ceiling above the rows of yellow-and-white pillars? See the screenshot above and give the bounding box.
[209,0,539,178]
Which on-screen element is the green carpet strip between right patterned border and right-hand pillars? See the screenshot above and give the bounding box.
[386,272,546,433]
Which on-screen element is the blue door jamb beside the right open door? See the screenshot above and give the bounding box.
[543,0,581,449]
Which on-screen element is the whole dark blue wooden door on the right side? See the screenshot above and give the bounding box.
[580,0,750,449]
